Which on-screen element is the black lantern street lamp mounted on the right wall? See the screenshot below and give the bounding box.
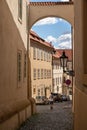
[60,51,68,72]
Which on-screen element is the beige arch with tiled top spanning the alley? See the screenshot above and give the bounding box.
[29,2,74,29]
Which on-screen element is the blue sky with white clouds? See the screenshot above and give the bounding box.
[31,0,72,49]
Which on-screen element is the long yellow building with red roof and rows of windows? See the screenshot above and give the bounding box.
[30,31,53,98]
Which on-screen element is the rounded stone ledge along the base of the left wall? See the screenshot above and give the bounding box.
[0,99,31,123]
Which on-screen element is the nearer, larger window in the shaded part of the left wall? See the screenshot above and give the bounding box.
[17,51,22,82]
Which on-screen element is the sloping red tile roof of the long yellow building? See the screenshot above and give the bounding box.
[30,31,53,48]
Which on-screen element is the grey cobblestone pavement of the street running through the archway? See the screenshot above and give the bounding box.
[19,101,73,130]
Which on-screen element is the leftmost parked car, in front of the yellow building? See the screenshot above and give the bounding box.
[35,96,49,105]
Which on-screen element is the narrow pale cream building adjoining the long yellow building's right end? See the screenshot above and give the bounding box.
[53,51,63,94]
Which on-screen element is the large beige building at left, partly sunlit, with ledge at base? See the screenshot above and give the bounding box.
[0,0,35,130]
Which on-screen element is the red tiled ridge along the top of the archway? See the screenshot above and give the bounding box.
[30,1,73,6]
